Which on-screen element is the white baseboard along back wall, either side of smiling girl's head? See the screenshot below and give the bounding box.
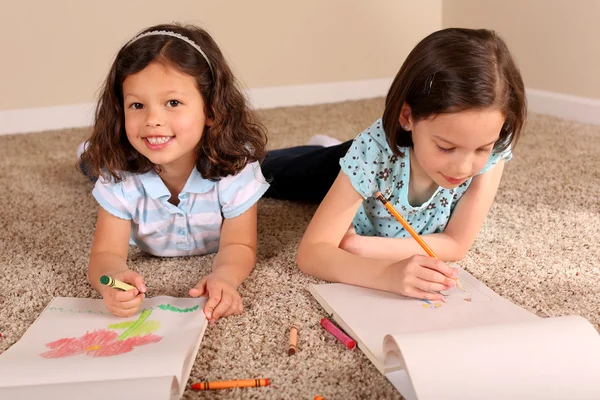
[0,78,392,135]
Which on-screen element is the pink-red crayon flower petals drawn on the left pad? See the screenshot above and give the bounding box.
[40,329,162,358]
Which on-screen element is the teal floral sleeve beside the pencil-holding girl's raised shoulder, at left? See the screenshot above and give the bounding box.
[340,132,383,199]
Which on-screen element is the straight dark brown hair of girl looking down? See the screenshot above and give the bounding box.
[383,28,527,154]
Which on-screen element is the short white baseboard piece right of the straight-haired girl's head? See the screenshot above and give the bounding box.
[527,89,600,125]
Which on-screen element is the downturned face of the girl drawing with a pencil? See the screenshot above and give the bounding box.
[400,109,505,189]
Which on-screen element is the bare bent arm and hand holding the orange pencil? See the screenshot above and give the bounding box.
[298,172,456,300]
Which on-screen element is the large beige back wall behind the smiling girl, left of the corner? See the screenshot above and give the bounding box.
[0,0,442,110]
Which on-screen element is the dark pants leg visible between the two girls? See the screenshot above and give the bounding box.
[261,140,352,203]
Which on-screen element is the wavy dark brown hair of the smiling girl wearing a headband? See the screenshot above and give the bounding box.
[80,24,267,181]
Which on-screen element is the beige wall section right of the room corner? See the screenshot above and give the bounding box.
[442,0,600,99]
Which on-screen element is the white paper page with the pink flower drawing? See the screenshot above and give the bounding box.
[0,297,207,396]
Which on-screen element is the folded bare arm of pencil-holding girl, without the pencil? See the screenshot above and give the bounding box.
[342,160,504,261]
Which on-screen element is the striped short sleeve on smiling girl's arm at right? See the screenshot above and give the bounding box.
[217,162,269,218]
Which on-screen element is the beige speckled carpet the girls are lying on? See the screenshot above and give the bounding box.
[0,99,600,399]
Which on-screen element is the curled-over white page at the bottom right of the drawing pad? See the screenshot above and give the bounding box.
[385,316,600,400]
